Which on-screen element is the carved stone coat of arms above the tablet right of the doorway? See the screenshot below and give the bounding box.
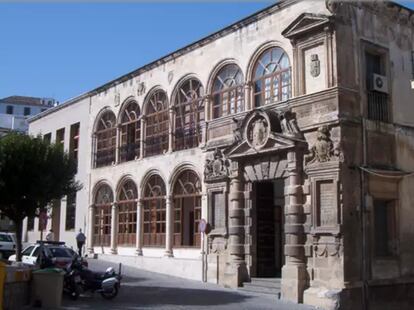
[305,125,343,165]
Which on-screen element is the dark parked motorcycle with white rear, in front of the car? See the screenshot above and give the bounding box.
[68,258,122,299]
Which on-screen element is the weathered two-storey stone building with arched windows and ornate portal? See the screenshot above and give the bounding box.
[27,0,414,309]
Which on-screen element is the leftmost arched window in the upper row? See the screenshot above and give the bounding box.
[95,111,116,167]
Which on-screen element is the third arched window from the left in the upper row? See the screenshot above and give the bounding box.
[145,90,169,156]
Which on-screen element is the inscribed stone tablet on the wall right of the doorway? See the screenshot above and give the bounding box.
[317,180,338,227]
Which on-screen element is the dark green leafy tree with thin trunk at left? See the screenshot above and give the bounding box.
[0,133,82,261]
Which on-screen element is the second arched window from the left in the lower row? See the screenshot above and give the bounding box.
[118,180,138,246]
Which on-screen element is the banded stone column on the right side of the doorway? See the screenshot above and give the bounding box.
[282,151,306,303]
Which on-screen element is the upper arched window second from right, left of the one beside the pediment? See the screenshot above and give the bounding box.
[212,64,244,118]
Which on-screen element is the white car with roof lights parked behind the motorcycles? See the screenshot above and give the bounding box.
[9,242,76,267]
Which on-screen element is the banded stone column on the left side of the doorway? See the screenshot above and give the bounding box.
[224,167,248,287]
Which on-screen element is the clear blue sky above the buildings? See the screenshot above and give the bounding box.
[0,1,414,101]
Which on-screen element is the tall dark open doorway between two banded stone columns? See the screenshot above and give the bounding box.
[255,182,282,277]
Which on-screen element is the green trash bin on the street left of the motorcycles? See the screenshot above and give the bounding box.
[31,268,65,309]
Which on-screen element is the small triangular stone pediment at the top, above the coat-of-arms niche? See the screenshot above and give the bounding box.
[282,13,331,39]
